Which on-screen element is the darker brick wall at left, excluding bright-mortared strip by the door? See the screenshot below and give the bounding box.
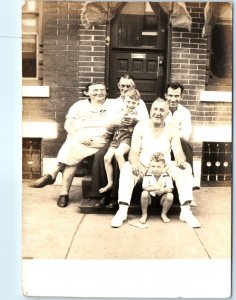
[23,1,81,157]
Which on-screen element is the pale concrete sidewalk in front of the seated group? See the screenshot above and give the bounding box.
[22,182,231,259]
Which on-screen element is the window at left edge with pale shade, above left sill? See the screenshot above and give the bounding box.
[22,0,43,85]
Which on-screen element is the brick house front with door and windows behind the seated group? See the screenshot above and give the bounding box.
[22,0,232,186]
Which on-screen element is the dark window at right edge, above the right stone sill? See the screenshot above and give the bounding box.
[206,3,232,91]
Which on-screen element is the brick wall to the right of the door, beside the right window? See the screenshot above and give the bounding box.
[171,2,232,156]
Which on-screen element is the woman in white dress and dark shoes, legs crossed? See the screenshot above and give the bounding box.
[29,83,115,207]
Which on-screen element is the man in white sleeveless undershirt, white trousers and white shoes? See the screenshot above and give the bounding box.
[111,98,201,228]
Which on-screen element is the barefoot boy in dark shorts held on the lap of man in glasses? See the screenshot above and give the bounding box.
[99,89,140,193]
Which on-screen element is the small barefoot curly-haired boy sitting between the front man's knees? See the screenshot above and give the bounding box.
[139,152,174,224]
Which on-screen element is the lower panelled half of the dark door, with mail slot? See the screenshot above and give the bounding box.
[109,49,166,106]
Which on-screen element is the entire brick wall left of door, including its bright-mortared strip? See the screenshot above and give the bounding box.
[23,0,106,157]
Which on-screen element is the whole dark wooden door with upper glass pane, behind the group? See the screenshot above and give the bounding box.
[108,4,167,108]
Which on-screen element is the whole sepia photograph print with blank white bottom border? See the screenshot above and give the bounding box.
[21,0,233,298]
